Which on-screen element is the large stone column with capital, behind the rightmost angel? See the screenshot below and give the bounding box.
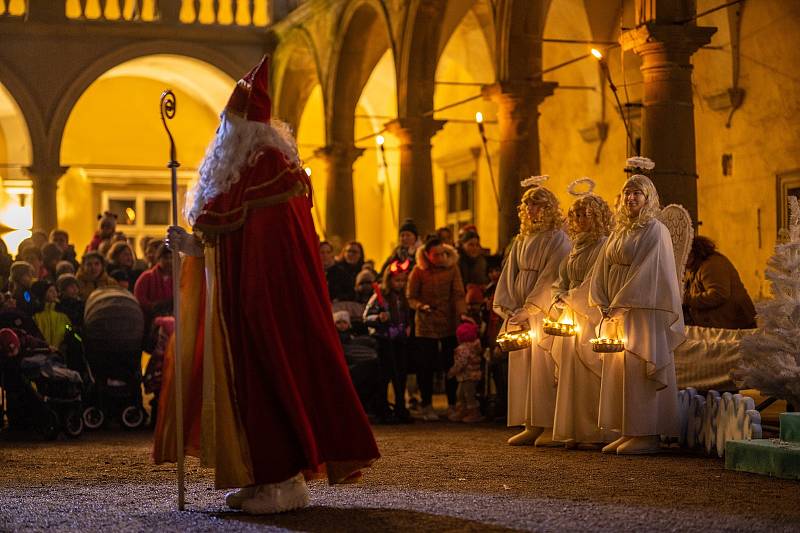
[620,19,716,224]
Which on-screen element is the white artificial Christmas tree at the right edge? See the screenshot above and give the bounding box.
[736,196,800,408]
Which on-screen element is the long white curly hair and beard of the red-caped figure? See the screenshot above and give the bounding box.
[183,111,300,225]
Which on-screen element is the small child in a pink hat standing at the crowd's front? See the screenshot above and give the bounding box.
[447,322,483,423]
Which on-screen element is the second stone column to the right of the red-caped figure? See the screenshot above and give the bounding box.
[386,117,445,238]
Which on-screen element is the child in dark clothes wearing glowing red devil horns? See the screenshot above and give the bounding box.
[364,260,411,422]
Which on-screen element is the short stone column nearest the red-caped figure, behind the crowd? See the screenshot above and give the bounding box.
[314,143,364,247]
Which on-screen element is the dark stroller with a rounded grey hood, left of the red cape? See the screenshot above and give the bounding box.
[83,288,146,429]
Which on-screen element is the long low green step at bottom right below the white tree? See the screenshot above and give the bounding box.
[725,439,800,479]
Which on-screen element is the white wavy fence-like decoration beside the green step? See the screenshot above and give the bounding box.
[678,388,762,457]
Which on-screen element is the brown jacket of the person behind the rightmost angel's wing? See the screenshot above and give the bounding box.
[683,253,756,329]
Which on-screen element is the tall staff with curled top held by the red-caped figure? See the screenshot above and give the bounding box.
[161,89,186,511]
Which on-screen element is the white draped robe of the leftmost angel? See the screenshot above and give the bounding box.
[494,230,570,428]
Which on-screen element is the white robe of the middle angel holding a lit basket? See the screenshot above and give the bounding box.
[551,234,619,443]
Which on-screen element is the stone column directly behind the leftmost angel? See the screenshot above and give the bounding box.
[483,81,558,250]
